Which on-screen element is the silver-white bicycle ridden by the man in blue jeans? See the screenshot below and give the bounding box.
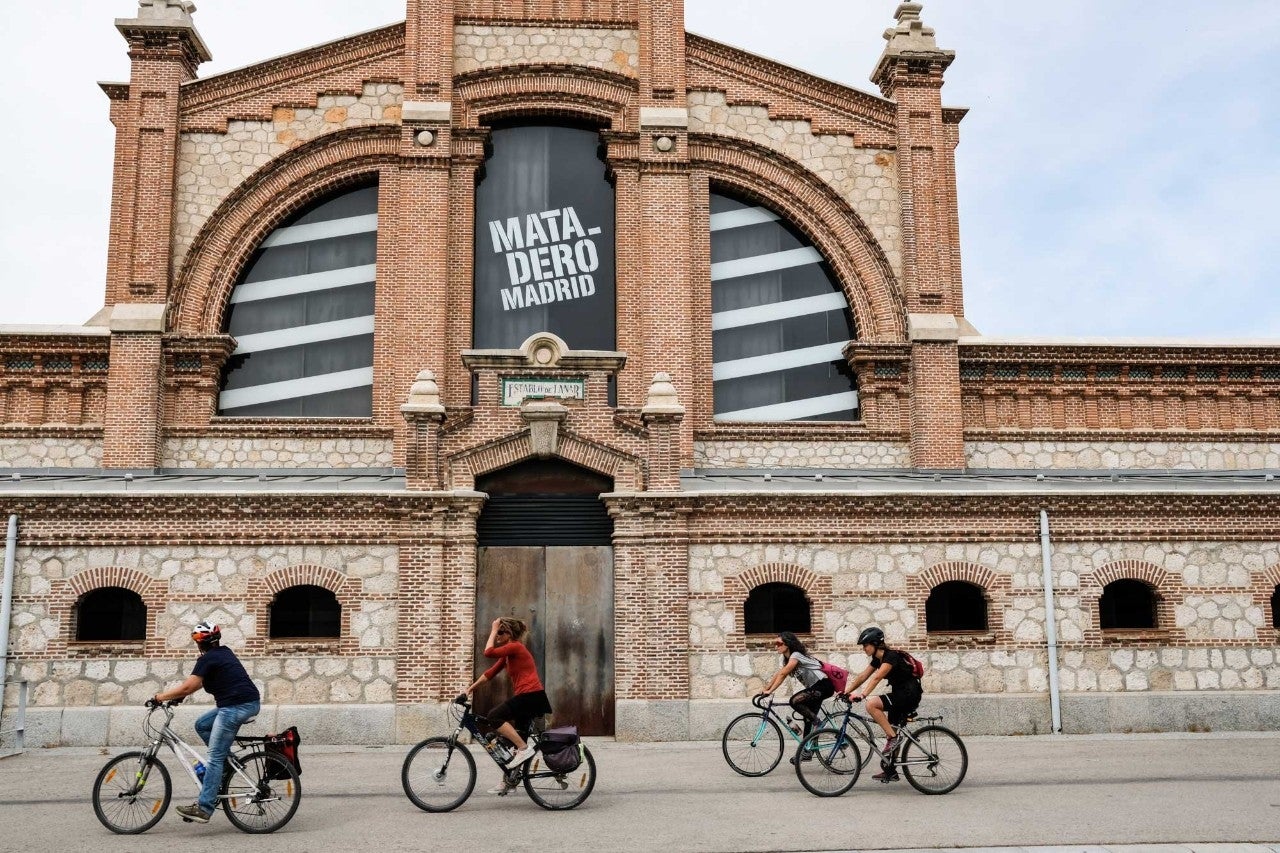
[93,699,302,835]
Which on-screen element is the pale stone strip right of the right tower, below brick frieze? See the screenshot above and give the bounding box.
[965,441,1280,471]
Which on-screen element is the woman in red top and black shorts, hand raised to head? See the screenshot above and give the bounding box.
[467,619,552,794]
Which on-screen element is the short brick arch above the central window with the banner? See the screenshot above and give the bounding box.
[453,63,639,129]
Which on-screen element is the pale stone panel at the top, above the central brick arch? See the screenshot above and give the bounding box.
[453,24,640,77]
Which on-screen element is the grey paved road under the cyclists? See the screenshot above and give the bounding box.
[0,734,1280,853]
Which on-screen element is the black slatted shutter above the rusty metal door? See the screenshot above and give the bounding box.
[476,494,613,547]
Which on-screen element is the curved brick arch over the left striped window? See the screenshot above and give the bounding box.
[168,126,399,334]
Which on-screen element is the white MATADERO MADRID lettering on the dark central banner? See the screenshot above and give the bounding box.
[489,207,602,311]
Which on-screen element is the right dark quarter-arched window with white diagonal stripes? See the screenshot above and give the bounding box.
[710,192,858,421]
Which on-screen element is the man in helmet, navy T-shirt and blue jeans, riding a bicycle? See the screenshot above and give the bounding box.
[152,621,262,824]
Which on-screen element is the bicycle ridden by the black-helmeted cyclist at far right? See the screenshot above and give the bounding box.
[796,703,969,797]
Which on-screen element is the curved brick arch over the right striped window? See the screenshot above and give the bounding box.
[689,133,908,342]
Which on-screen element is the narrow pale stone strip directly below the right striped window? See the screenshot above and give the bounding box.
[694,441,911,469]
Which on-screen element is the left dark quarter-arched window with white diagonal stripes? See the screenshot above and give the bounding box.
[218,186,378,418]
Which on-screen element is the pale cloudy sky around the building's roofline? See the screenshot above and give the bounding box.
[0,0,1280,339]
